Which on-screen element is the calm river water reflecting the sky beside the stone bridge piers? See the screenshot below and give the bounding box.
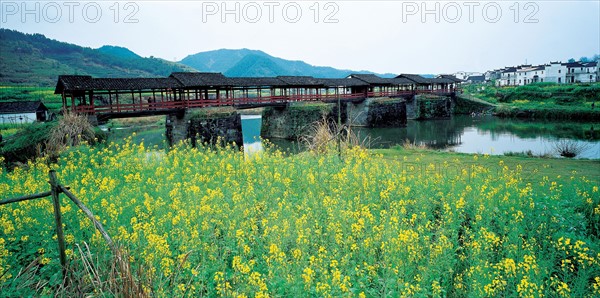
[242,116,600,159]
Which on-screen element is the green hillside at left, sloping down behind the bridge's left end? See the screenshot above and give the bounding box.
[0,29,194,86]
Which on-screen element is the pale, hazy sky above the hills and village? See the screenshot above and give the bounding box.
[0,0,600,74]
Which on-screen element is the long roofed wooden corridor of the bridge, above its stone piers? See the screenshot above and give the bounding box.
[55,72,460,120]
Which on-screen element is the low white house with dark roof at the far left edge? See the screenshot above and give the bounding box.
[0,101,49,124]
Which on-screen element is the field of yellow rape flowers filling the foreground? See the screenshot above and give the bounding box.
[0,141,600,297]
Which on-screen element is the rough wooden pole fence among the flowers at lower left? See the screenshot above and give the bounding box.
[0,170,117,277]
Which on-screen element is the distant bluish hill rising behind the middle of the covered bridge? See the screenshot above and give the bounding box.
[179,49,394,78]
